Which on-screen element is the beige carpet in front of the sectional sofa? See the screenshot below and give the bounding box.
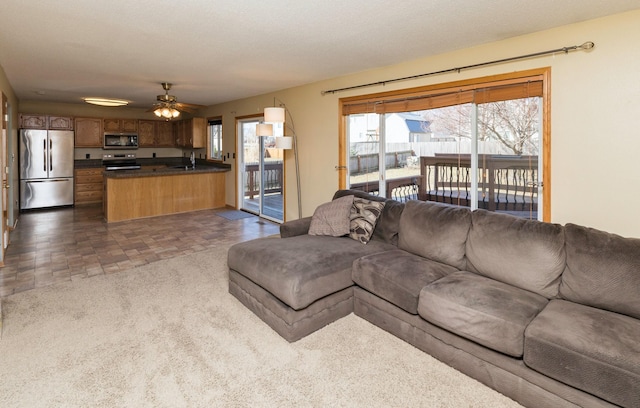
[0,244,519,408]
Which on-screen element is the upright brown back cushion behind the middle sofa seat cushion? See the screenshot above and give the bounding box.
[466,210,566,298]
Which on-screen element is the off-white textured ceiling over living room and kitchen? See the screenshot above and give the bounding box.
[0,0,640,107]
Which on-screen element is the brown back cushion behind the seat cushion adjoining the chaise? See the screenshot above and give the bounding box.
[398,200,471,269]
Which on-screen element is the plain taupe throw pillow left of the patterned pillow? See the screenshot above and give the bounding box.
[309,195,353,237]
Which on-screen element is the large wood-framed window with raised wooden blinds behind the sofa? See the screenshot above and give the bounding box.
[339,69,550,220]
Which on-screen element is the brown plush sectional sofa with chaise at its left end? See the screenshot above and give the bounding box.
[228,190,640,407]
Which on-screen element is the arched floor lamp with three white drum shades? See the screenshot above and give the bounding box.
[256,98,302,218]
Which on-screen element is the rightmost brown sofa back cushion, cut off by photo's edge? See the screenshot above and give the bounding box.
[560,224,640,319]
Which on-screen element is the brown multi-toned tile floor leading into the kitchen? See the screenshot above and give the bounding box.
[0,206,279,297]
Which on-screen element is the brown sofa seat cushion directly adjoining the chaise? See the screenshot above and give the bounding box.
[352,249,457,314]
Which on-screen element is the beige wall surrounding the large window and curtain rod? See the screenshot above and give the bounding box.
[203,11,640,237]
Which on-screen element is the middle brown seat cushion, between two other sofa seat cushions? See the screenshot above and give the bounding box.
[418,271,548,357]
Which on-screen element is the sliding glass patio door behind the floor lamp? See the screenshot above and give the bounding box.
[237,117,284,223]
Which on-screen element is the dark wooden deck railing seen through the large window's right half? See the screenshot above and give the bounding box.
[419,155,538,212]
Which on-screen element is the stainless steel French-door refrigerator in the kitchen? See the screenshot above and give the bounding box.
[20,129,74,210]
